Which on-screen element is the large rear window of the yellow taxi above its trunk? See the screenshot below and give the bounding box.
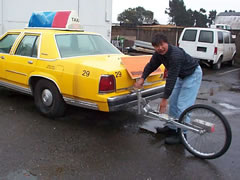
[56,34,121,58]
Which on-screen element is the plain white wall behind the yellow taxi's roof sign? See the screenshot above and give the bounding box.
[0,0,112,40]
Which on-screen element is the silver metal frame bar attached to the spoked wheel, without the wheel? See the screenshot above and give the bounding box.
[136,89,206,134]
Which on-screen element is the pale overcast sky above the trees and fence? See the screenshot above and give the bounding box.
[112,0,240,24]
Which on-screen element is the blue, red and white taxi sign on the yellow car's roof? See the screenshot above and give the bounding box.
[28,11,81,29]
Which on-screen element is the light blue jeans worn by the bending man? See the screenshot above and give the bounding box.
[166,66,202,129]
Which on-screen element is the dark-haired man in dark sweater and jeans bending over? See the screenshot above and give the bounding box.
[134,34,202,144]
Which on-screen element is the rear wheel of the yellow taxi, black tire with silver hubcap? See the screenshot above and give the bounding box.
[34,79,66,118]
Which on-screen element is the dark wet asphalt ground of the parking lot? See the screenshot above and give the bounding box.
[0,66,240,180]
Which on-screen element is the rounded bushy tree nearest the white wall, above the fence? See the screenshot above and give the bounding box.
[117,6,156,25]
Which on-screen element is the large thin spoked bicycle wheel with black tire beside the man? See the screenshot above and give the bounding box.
[179,104,232,159]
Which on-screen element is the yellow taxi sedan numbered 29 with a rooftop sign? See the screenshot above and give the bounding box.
[0,11,165,117]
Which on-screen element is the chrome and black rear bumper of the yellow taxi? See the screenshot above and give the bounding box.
[108,85,165,111]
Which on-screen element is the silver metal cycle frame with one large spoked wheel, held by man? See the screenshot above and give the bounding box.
[136,89,232,159]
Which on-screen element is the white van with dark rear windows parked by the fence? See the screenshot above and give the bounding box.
[179,28,236,69]
